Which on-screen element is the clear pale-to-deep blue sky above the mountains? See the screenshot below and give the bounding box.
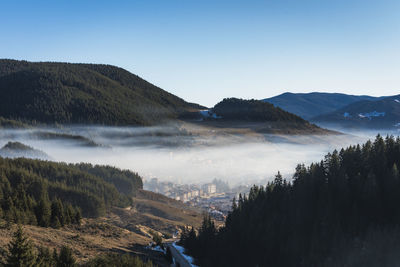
[0,0,400,106]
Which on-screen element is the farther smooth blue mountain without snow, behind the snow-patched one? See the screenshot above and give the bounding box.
[263,93,380,120]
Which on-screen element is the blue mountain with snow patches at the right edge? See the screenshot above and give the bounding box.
[312,95,400,129]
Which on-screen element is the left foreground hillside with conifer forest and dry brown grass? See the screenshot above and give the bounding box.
[0,157,201,266]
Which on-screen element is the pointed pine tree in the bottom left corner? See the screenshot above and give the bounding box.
[6,225,35,267]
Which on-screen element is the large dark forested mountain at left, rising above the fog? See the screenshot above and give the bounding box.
[0,60,202,125]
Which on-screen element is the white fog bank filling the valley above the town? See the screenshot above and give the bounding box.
[0,126,393,185]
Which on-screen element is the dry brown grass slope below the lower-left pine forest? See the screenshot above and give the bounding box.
[0,190,202,266]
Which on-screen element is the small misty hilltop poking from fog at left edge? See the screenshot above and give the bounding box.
[0,142,50,159]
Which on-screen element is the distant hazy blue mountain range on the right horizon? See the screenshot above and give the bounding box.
[263,93,400,129]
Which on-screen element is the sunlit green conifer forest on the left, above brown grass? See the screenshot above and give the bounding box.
[0,157,143,227]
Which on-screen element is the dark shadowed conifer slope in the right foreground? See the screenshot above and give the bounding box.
[182,136,400,266]
